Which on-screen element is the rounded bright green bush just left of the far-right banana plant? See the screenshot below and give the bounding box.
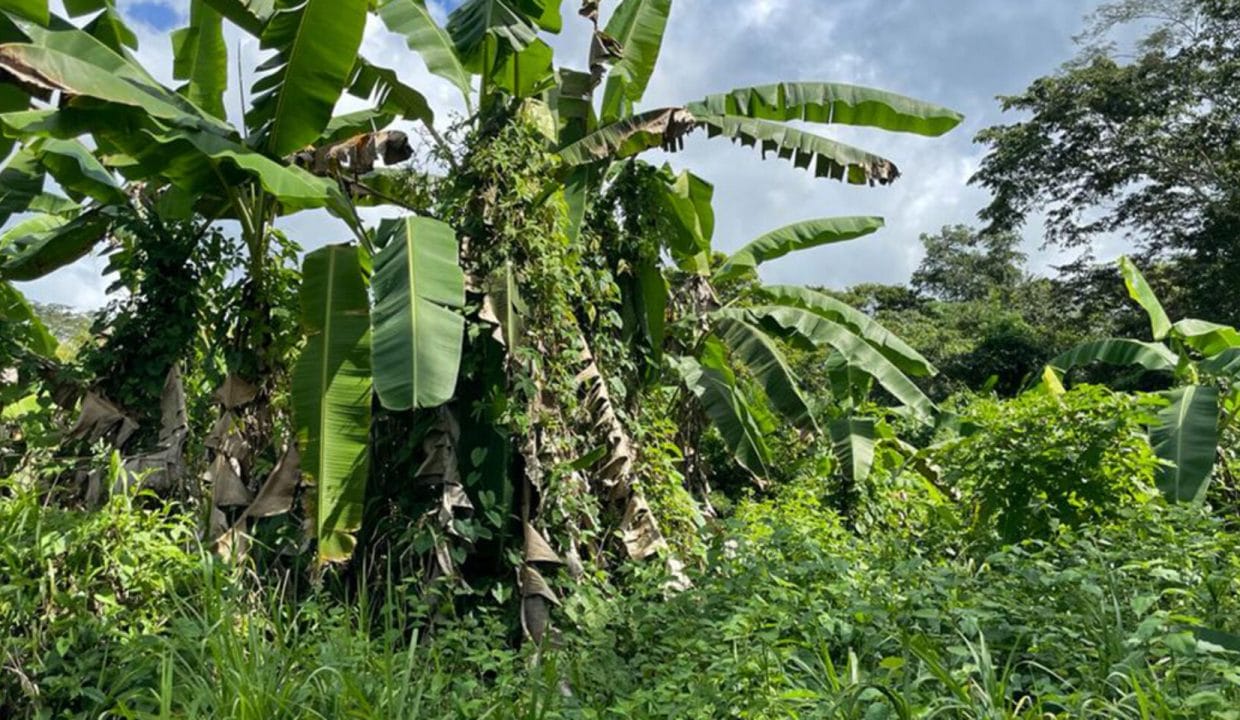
[934,385,1161,543]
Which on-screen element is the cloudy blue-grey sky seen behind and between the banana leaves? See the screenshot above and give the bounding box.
[12,0,1120,307]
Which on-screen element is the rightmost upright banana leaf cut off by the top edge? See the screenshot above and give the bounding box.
[601,0,672,123]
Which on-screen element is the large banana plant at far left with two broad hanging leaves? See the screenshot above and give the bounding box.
[0,0,464,561]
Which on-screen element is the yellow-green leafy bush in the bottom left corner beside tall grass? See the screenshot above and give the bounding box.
[0,465,205,718]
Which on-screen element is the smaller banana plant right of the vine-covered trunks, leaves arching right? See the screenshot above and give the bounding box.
[640,164,936,480]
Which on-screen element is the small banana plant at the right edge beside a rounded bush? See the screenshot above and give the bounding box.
[1044,257,1240,503]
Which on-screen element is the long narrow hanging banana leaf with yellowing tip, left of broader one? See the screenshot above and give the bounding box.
[293,245,372,563]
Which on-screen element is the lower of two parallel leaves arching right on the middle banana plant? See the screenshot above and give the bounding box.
[739,305,936,420]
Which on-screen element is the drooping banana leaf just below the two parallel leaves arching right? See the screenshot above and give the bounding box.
[715,311,818,431]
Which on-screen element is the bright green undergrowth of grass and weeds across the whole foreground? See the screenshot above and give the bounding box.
[0,463,1240,719]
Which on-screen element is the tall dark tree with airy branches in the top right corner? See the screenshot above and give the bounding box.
[973,0,1240,322]
